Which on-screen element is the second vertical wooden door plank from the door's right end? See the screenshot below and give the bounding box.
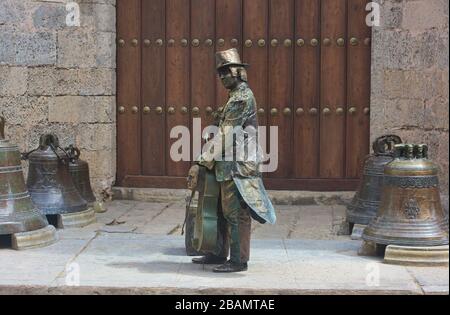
[320,0,347,178]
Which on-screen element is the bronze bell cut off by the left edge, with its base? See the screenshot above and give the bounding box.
[0,117,56,249]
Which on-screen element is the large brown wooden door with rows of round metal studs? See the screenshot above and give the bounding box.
[117,0,371,190]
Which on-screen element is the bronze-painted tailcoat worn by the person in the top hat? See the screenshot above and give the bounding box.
[198,82,276,224]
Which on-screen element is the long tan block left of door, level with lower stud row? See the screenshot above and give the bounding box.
[48,96,115,124]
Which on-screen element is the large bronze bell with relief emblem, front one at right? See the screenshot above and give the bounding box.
[362,144,448,246]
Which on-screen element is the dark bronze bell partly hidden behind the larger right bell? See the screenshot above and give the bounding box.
[347,135,402,225]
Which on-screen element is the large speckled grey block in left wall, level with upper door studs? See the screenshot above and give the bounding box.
[15,32,56,66]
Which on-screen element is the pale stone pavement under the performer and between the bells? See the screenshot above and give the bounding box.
[0,200,449,294]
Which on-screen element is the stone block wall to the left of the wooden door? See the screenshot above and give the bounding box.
[0,0,116,200]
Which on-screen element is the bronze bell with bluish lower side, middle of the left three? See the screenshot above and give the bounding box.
[26,134,88,220]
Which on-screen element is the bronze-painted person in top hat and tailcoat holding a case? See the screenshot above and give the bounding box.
[190,49,276,272]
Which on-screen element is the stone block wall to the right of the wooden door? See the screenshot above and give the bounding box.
[371,0,449,207]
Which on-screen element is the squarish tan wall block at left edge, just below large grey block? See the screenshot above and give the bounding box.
[0,66,28,96]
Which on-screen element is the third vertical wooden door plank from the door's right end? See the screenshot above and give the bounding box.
[294,0,321,178]
